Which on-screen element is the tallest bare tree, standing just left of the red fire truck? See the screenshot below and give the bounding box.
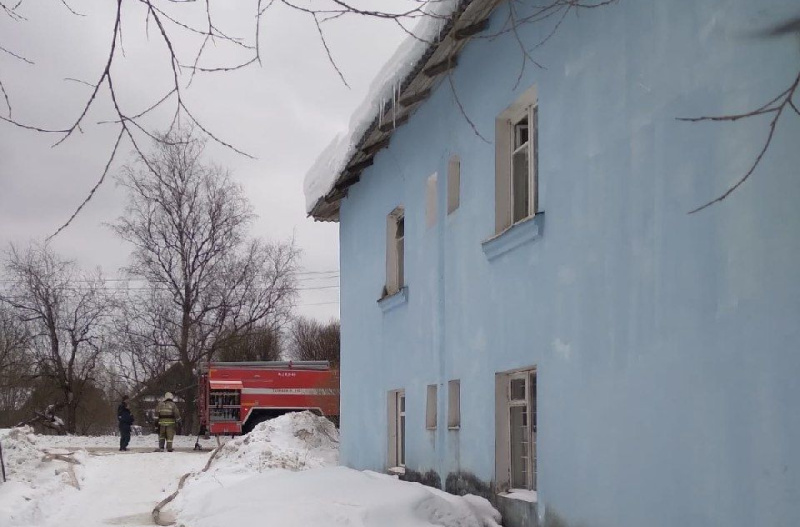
[113,130,298,428]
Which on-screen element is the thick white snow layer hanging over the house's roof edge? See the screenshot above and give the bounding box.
[303,0,462,214]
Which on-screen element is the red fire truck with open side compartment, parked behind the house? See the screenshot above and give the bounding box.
[197,361,339,435]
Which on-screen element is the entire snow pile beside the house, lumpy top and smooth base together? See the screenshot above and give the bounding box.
[173,412,500,527]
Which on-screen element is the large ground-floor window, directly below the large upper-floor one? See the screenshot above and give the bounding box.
[495,368,537,490]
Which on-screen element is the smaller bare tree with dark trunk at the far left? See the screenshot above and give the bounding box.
[0,245,112,432]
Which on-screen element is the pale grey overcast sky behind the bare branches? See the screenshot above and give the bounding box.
[0,0,414,320]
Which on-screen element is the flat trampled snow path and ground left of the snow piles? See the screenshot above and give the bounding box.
[0,429,209,527]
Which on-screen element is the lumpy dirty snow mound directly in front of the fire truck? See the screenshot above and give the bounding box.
[211,412,339,472]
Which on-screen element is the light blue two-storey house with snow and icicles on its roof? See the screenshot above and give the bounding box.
[306,0,800,527]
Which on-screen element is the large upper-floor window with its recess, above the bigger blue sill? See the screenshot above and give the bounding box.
[495,86,539,233]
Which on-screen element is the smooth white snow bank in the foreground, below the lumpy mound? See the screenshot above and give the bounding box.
[178,467,500,527]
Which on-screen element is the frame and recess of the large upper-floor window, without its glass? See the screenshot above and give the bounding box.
[495,86,539,234]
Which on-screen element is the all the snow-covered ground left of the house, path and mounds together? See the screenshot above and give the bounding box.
[0,412,499,527]
